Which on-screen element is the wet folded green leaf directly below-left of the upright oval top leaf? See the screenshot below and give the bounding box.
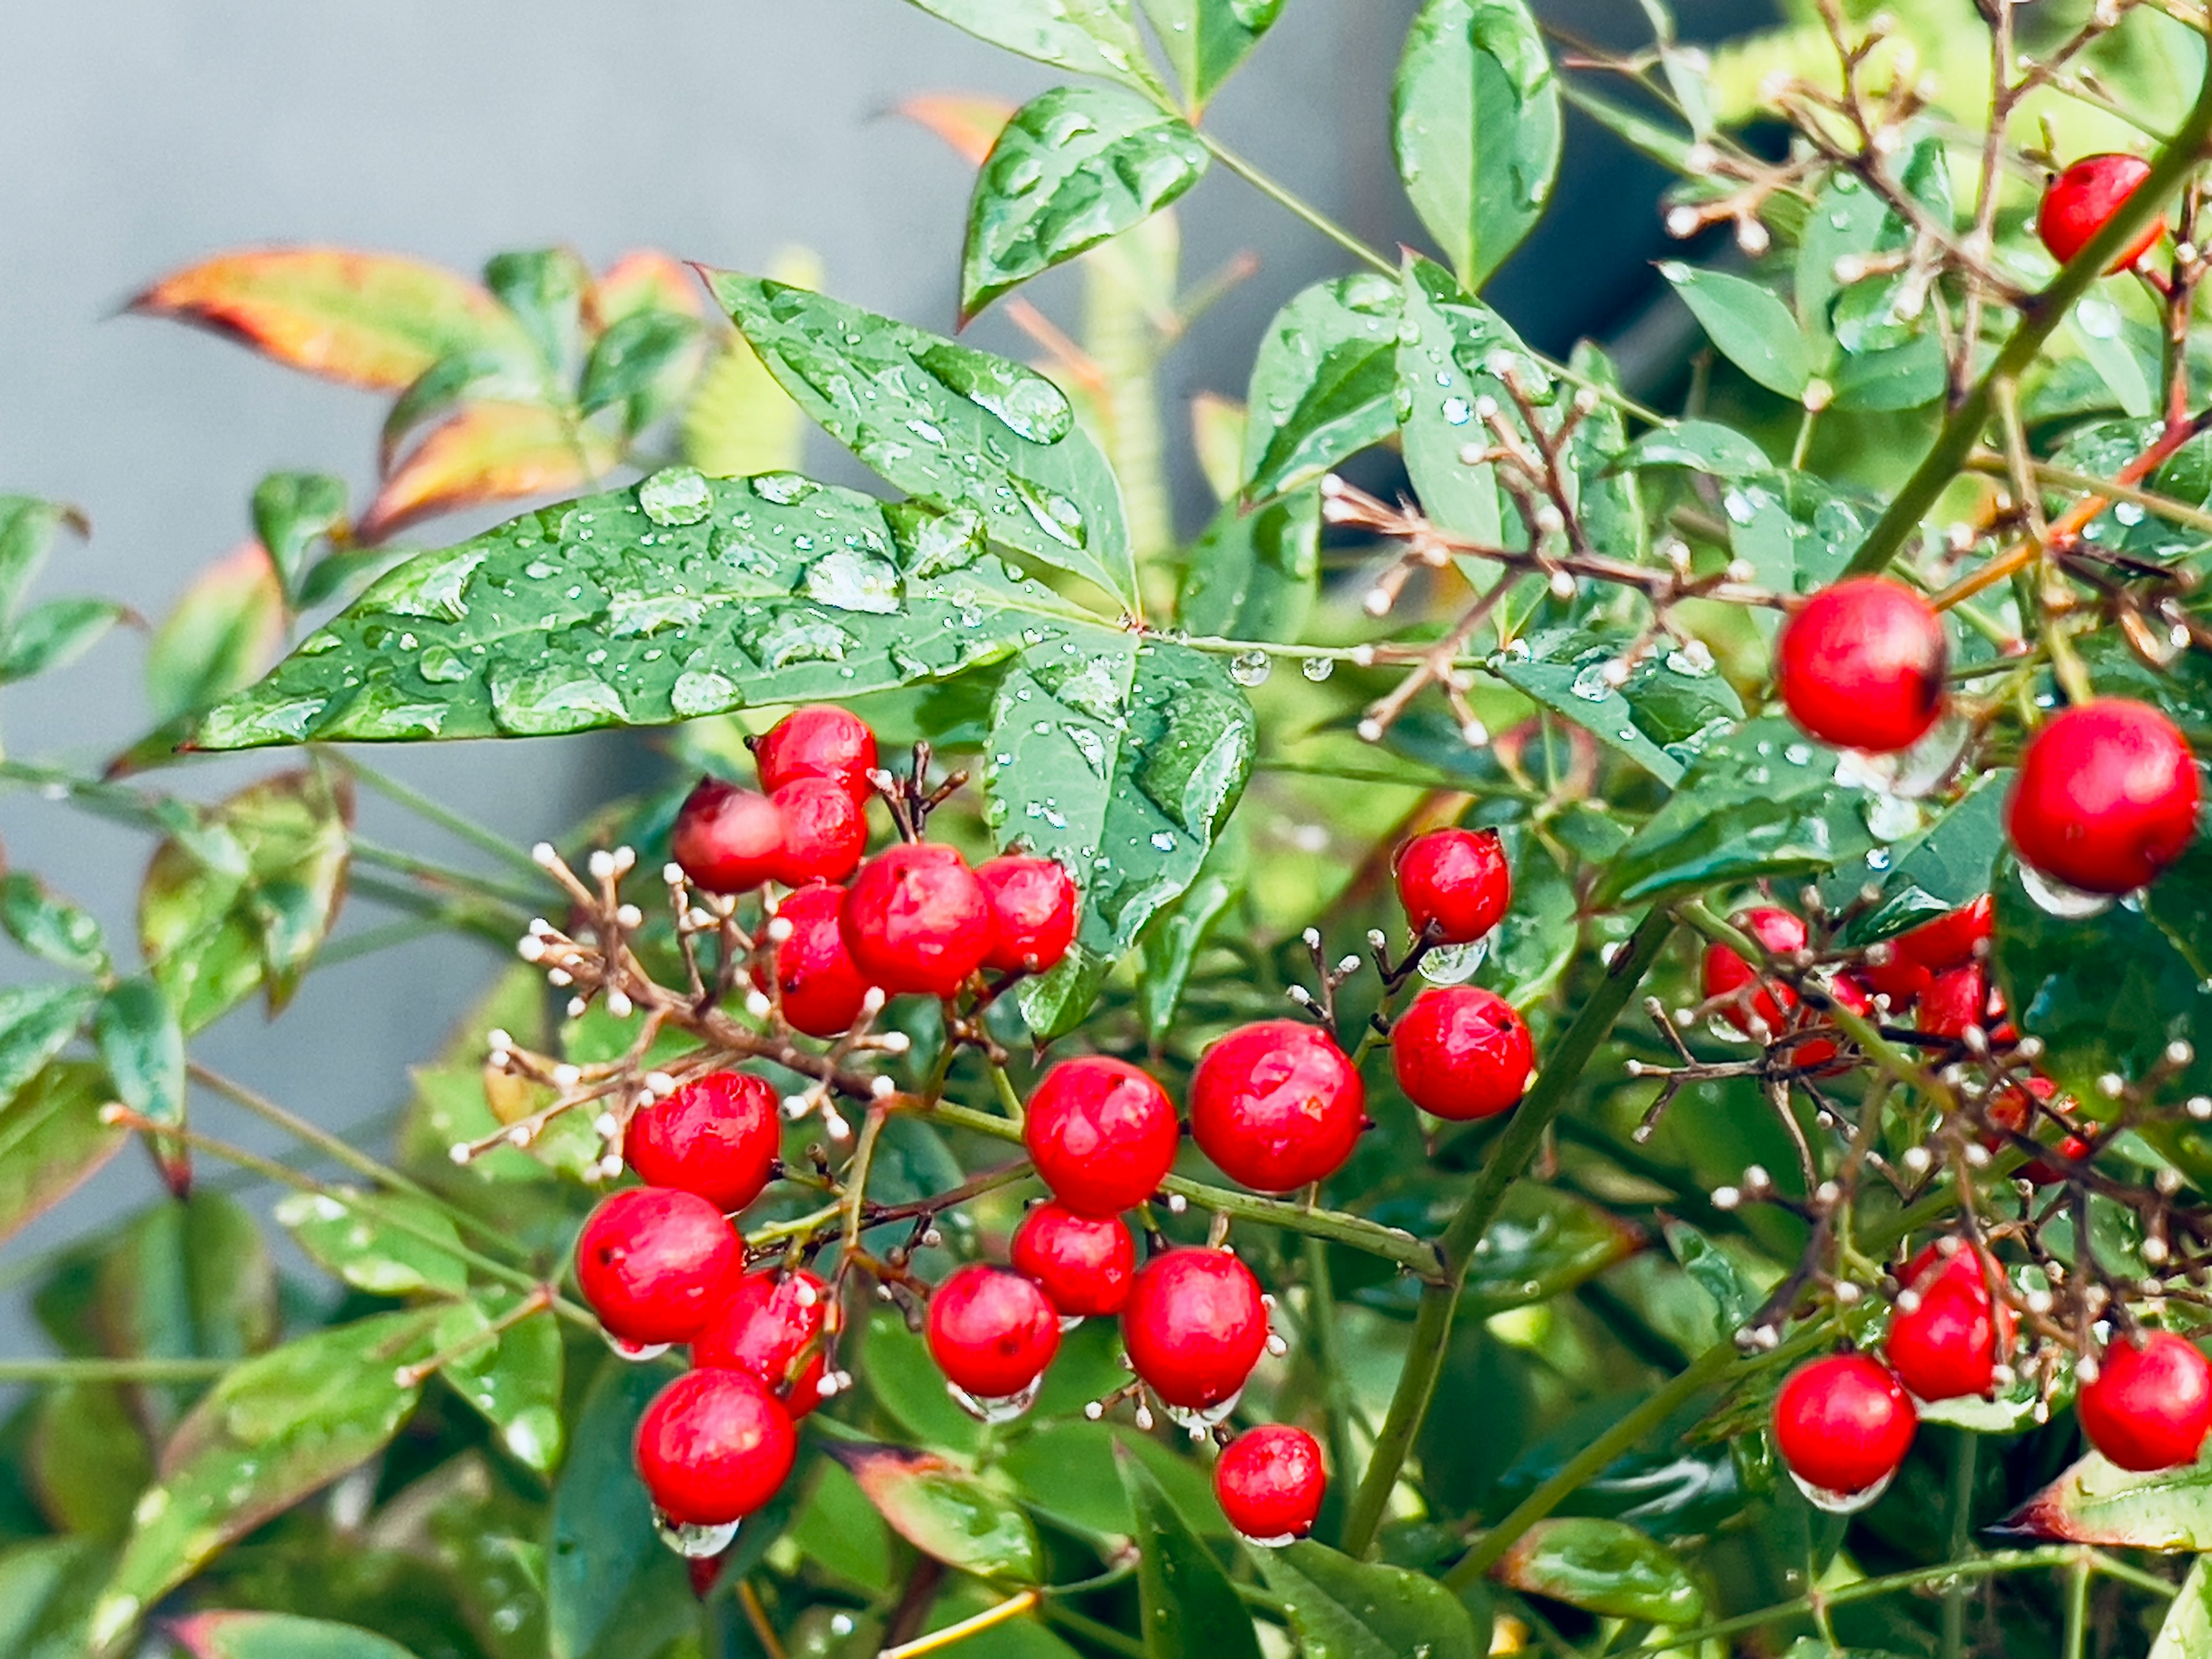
[1243,270,1403,502]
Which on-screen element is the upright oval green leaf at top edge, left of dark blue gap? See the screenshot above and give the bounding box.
[1391,0,1559,292]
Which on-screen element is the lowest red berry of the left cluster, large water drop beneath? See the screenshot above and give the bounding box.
[637,1372,798,1527]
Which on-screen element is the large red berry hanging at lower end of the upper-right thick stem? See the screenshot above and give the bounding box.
[1774,575,1951,754]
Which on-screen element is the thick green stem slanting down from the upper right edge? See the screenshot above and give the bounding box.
[1845,62,2212,575]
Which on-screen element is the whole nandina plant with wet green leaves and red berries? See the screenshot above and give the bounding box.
[0,0,2212,1659]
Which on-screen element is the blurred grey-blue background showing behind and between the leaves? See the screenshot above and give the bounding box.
[0,0,1772,1354]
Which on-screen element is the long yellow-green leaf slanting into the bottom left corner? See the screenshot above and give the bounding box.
[90,1314,429,1654]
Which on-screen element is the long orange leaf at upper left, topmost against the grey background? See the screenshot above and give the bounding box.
[131,248,529,392]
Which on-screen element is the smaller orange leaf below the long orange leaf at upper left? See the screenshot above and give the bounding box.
[358,403,619,542]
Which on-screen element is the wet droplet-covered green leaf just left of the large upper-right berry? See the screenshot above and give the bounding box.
[1491,628,1743,785]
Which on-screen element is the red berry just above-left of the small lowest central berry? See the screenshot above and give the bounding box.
[1122,1248,1267,1411]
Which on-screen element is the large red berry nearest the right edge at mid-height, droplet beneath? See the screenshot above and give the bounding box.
[2006,697,2196,893]
